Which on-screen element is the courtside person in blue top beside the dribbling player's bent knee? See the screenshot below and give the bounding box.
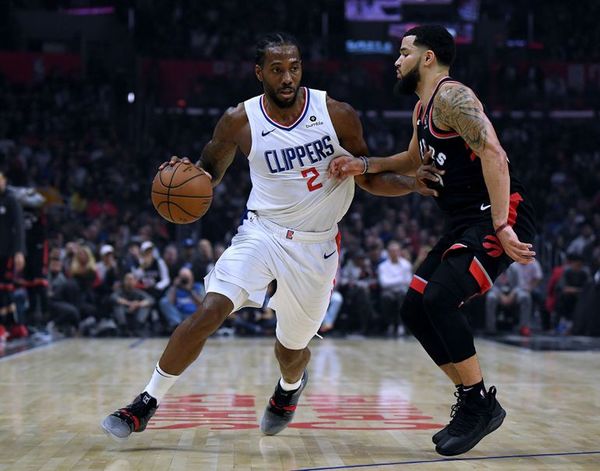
[159,267,204,331]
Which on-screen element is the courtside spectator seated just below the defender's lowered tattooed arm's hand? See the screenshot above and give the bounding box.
[485,263,531,337]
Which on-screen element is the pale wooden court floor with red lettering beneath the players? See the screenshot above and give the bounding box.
[0,339,600,471]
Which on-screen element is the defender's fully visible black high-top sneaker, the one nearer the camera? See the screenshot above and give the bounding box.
[435,386,506,456]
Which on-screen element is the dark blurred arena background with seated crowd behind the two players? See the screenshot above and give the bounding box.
[0,0,600,337]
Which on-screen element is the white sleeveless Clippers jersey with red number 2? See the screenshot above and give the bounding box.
[244,88,354,232]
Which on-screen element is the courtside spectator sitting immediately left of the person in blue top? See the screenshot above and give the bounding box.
[112,273,154,336]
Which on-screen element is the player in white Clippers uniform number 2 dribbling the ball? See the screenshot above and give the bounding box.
[102,34,433,439]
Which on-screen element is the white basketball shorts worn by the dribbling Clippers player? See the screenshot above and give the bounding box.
[204,212,339,350]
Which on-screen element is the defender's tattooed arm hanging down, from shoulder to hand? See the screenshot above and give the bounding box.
[433,84,535,263]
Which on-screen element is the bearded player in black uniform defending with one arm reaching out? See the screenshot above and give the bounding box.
[330,26,535,456]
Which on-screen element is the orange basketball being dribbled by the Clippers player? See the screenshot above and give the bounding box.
[152,162,212,224]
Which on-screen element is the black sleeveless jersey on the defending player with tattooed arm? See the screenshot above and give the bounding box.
[417,77,523,227]
